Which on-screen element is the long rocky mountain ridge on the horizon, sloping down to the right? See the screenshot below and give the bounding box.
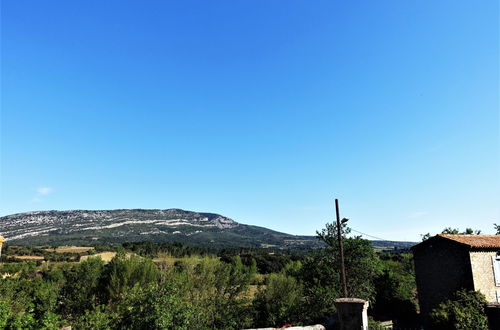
[0,208,413,250]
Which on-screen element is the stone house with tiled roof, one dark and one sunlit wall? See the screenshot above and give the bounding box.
[412,234,500,321]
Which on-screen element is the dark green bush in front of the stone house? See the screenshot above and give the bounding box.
[430,290,488,330]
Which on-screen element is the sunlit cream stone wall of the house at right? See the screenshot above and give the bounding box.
[470,251,500,302]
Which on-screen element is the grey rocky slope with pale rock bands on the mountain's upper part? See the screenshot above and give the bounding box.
[0,209,239,242]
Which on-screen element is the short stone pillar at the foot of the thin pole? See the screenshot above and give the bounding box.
[335,298,369,330]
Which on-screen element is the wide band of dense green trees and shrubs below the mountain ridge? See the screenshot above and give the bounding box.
[0,225,417,329]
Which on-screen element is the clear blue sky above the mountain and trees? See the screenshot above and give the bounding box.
[0,0,500,240]
